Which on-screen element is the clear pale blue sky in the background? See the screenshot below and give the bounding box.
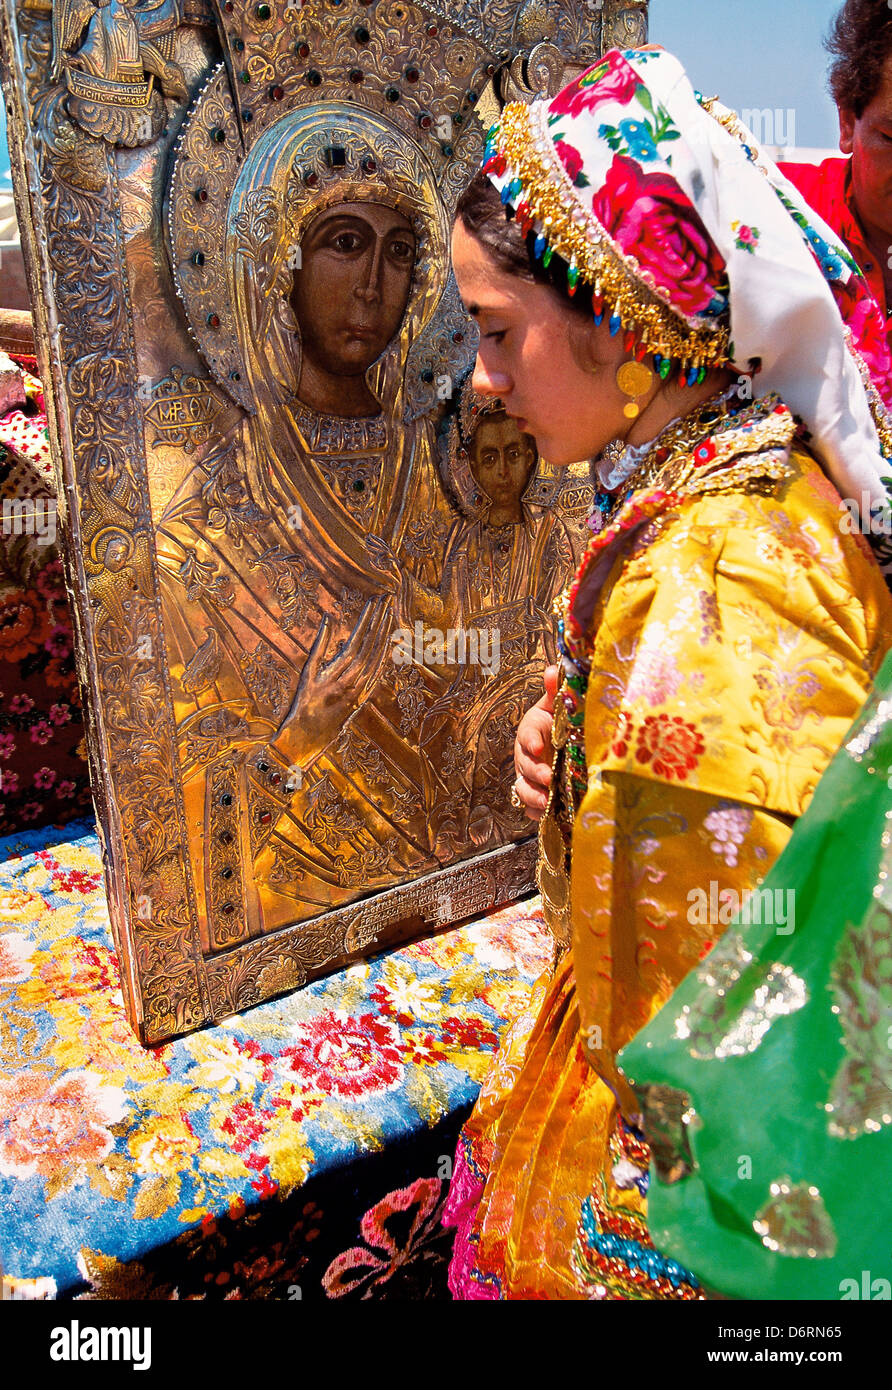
[0,0,841,190]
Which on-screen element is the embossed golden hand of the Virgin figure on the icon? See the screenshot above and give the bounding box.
[272,596,393,767]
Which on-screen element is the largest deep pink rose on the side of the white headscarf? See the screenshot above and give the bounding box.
[592,154,725,314]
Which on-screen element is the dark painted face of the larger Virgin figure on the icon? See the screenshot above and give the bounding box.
[292,203,415,377]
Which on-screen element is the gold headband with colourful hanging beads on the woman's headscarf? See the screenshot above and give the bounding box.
[484,101,729,386]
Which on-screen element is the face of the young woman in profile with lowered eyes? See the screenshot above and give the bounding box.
[452,221,644,466]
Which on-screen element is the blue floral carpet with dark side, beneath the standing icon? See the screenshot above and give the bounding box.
[0,819,550,1300]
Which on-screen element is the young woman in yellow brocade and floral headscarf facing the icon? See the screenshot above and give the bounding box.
[447,50,892,1298]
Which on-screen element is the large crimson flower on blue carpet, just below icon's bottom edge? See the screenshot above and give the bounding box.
[281,1009,404,1101]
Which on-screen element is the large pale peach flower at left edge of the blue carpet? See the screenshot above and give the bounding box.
[0,1072,126,1177]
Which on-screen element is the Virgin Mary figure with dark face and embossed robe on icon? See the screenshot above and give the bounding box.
[157,103,454,949]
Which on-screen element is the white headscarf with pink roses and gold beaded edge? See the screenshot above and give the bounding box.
[484,50,892,522]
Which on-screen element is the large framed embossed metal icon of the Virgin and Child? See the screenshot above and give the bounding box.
[3,0,645,1043]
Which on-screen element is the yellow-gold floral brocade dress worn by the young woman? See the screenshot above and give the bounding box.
[453,396,892,1298]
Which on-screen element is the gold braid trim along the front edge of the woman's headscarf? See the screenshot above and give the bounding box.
[497,101,729,370]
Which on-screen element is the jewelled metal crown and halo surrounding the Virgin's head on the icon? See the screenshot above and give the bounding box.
[167,0,493,420]
